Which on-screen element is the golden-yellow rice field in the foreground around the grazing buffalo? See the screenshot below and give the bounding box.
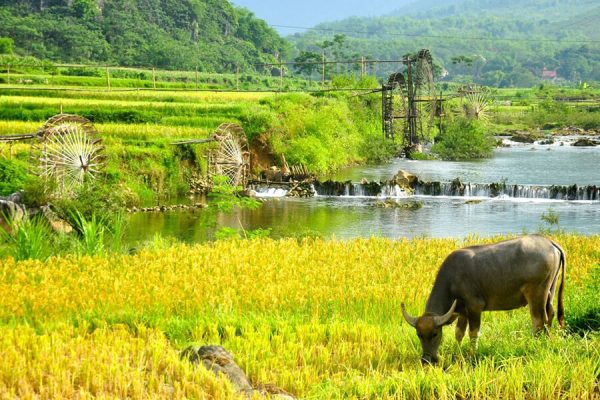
[0,235,600,399]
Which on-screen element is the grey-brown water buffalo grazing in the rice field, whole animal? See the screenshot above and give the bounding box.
[402,235,566,363]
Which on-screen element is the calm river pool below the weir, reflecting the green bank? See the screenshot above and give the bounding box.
[128,198,600,242]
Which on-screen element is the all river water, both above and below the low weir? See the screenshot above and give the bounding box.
[127,141,600,243]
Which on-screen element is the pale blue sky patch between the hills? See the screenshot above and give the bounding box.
[232,0,407,35]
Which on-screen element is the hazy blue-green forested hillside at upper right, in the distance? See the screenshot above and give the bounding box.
[290,0,600,87]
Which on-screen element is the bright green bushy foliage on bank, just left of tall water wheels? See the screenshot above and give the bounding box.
[270,95,394,173]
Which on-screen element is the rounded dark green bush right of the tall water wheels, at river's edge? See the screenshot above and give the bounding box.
[431,118,494,160]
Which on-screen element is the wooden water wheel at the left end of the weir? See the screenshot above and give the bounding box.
[208,123,250,187]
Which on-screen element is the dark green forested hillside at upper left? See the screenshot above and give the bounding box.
[0,0,289,72]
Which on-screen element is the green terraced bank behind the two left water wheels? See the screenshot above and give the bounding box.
[0,87,393,206]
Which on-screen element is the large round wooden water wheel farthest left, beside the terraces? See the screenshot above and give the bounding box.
[31,114,105,193]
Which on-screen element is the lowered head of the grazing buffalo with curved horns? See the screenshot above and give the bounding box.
[402,300,457,364]
